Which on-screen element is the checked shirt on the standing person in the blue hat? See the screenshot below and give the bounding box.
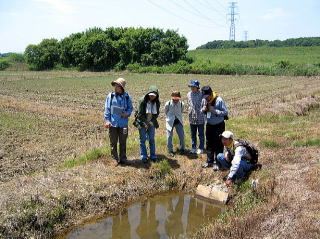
[187,90,204,124]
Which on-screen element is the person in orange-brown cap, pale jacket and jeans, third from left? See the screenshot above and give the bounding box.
[164,91,185,156]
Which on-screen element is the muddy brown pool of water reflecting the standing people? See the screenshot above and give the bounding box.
[66,193,224,239]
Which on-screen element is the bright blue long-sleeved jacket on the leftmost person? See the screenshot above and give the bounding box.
[104,92,133,128]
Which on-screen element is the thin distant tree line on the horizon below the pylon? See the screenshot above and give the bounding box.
[197,37,320,49]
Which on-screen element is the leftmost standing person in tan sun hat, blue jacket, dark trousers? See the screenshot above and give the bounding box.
[104,78,133,165]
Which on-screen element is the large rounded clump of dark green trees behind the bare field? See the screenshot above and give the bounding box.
[24,27,188,71]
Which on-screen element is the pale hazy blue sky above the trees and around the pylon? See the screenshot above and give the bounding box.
[0,0,320,53]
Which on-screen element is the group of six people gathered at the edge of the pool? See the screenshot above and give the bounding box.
[104,78,251,184]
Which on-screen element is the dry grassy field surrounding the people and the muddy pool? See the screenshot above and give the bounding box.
[0,71,320,238]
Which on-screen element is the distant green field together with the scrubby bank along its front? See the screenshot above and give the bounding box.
[127,47,320,76]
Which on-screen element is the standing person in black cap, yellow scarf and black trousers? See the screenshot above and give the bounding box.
[201,86,228,170]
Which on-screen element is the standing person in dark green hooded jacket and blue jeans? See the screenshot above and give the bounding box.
[133,86,160,163]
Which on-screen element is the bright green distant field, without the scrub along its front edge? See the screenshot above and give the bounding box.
[188,47,320,65]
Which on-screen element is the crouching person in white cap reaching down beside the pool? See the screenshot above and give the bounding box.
[216,131,252,186]
